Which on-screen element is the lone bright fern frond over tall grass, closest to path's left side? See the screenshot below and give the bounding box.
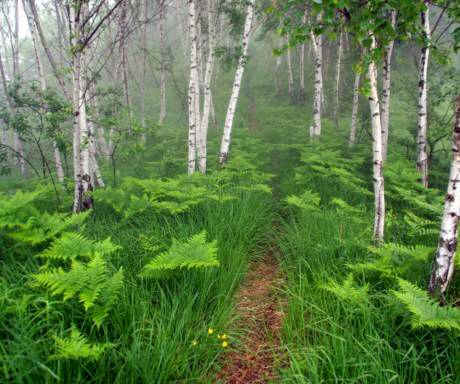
[141,231,219,277]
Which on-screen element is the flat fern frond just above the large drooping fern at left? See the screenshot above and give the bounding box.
[39,232,120,260]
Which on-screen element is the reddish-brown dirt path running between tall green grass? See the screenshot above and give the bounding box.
[218,252,283,384]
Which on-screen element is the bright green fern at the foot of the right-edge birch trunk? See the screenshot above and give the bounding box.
[393,279,460,331]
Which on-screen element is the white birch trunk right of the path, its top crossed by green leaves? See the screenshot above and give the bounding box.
[368,36,385,243]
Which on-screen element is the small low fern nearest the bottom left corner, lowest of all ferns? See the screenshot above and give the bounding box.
[50,327,113,361]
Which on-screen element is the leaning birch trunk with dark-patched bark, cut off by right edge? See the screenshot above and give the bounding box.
[428,95,460,301]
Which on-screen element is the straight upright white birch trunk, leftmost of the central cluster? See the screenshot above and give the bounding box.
[188,0,200,175]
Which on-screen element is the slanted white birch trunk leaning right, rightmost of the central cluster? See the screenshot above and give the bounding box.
[219,0,254,165]
